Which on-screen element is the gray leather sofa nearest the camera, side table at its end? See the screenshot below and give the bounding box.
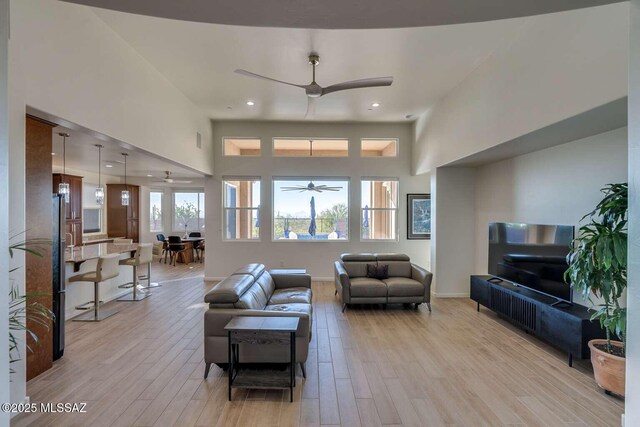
[204,264,312,378]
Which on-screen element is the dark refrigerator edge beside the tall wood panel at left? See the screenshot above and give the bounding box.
[52,194,66,360]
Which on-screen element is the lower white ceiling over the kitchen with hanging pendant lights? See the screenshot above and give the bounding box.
[52,126,203,184]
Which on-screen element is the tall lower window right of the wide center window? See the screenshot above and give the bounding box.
[360,178,398,240]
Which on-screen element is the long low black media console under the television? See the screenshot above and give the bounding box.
[470,276,605,366]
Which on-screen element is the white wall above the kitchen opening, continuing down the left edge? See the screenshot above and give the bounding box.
[6,0,213,402]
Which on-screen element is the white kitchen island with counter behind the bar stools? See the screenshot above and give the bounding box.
[65,243,138,319]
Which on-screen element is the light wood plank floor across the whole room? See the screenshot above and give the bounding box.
[13,265,623,426]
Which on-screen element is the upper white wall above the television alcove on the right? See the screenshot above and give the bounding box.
[412,3,629,173]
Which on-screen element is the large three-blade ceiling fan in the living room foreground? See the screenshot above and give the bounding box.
[235,53,393,117]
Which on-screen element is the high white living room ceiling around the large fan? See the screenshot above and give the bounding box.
[94,9,536,121]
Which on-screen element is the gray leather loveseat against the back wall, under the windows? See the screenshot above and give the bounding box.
[335,253,433,311]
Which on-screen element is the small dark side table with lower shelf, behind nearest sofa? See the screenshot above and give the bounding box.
[224,316,300,402]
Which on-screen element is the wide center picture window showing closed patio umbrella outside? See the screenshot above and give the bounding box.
[273,177,349,241]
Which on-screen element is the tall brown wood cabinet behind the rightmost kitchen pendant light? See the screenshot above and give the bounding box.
[107,184,140,242]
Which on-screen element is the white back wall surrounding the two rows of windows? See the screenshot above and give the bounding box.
[205,121,430,278]
